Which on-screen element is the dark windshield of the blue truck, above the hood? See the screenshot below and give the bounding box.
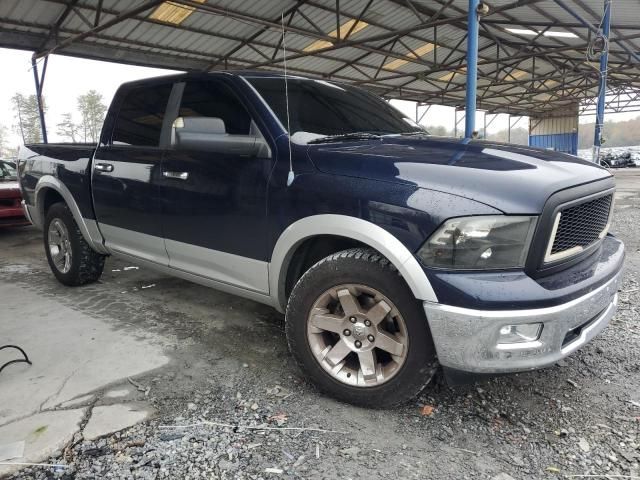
[247,77,423,136]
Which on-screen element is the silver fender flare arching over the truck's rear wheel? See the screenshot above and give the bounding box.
[32,175,108,254]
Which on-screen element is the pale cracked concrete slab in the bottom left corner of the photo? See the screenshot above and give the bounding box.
[0,409,85,477]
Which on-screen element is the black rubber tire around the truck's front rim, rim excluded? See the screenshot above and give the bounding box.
[285,248,437,408]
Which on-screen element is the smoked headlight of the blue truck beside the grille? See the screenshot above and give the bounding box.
[418,215,537,269]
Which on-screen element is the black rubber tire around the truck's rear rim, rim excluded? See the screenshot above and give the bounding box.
[44,202,106,287]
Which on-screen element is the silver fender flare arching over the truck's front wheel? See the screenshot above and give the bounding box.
[269,214,438,311]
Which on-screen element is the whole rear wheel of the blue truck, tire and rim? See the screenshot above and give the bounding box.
[44,203,105,286]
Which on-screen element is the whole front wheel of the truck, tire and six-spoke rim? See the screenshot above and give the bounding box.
[286,248,436,407]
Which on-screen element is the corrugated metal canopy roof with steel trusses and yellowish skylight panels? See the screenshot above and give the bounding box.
[0,0,640,115]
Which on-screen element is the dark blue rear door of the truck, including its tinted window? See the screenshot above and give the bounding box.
[92,82,173,266]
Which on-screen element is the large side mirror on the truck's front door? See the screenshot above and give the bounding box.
[171,117,270,157]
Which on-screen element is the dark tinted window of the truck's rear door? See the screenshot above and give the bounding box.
[111,84,172,147]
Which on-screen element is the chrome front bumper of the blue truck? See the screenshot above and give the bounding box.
[424,270,621,375]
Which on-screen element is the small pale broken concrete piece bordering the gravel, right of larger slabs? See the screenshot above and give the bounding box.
[83,403,153,440]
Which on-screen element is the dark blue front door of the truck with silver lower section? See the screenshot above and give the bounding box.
[161,77,273,293]
